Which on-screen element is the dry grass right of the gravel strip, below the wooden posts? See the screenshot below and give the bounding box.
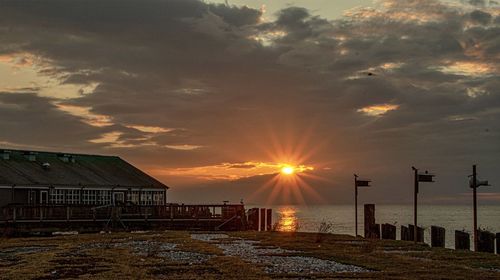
[230,232,500,279]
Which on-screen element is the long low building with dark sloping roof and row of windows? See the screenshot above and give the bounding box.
[0,149,168,207]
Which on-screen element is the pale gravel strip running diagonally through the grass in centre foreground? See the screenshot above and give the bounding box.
[191,234,368,274]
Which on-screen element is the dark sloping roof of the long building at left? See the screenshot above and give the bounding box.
[0,149,168,188]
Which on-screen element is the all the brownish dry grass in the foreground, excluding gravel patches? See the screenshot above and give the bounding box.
[0,231,500,279]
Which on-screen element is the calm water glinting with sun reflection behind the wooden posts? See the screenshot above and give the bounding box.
[254,205,500,248]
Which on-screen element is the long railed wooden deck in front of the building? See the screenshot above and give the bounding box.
[0,204,247,231]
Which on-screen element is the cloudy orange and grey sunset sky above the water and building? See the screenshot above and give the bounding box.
[0,0,500,204]
